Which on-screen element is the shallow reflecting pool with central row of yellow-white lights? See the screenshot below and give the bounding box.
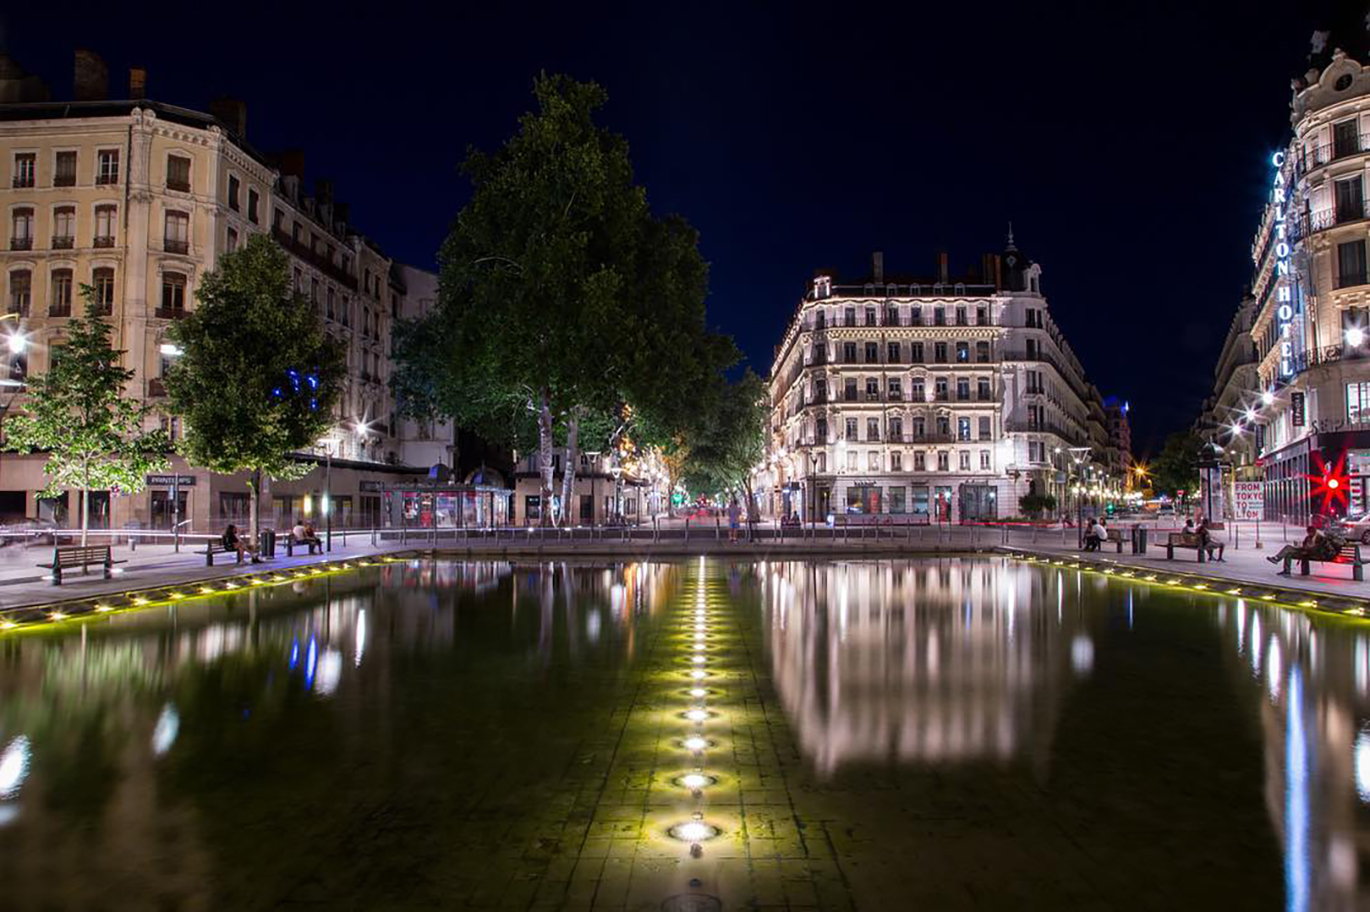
[0,559,1370,911]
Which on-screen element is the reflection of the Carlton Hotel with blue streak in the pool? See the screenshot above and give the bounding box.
[1218,600,1370,909]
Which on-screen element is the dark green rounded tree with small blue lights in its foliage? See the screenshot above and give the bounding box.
[166,234,344,537]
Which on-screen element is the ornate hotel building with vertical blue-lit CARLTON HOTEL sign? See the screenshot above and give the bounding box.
[1233,37,1370,522]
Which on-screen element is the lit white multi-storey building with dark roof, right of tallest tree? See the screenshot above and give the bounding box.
[759,236,1130,522]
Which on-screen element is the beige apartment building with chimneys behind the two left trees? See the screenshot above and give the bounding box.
[0,52,432,529]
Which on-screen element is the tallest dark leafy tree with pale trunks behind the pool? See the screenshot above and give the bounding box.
[395,75,736,523]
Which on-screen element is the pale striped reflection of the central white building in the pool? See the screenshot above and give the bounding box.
[764,560,1093,772]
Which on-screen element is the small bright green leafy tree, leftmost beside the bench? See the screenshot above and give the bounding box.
[4,286,171,545]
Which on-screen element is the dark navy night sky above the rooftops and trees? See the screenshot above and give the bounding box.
[0,0,1363,455]
